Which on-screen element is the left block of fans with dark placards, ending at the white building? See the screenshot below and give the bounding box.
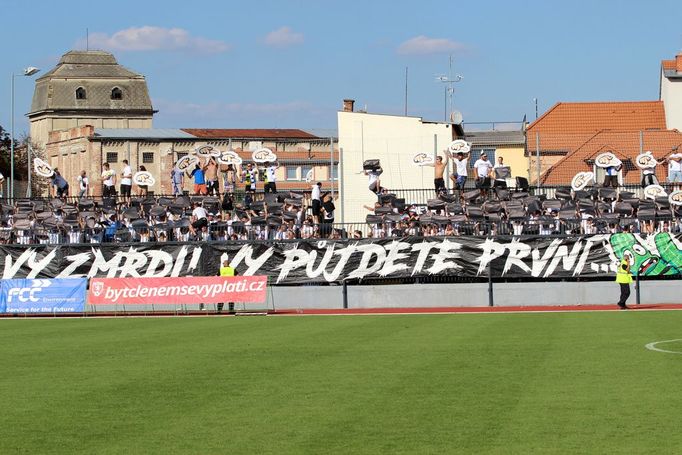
[0,189,341,245]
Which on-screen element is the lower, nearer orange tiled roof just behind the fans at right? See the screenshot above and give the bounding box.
[542,130,682,185]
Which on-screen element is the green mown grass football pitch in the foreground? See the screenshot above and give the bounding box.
[0,311,682,454]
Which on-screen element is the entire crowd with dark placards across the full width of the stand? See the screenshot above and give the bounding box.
[0,184,682,244]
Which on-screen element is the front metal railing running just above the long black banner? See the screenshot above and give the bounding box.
[0,217,682,245]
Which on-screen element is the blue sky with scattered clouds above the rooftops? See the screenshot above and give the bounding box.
[0,0,682,134]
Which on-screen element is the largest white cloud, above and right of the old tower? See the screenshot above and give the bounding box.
[78,25,230,54]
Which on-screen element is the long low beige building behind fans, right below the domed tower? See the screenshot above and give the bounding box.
[46,126,338,196]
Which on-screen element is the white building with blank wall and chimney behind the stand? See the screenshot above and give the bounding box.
[337,100,463,223]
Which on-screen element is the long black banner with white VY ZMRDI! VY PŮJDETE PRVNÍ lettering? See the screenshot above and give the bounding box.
[0,233,682,284]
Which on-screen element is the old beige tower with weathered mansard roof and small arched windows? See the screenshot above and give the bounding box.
[28,51,156,149]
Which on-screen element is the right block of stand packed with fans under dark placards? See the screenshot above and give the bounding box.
[367,187,682,237]
